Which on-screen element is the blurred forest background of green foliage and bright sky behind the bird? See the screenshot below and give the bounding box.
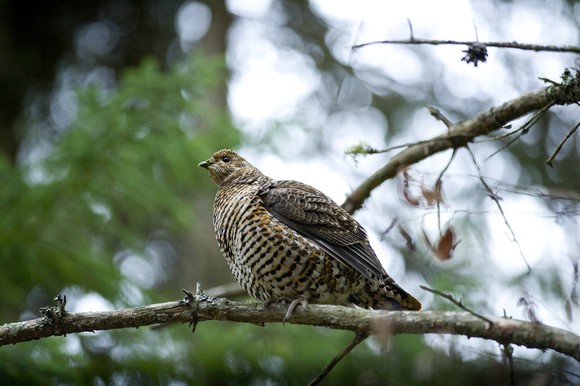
[0,0,580,385]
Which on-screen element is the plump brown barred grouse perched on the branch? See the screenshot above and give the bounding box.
[199,149,422,322]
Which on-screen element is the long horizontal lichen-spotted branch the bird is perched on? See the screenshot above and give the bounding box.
[0,296,580,360]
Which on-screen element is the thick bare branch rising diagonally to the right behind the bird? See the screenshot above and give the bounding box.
[342,84,580,213]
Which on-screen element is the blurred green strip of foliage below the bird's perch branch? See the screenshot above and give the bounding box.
[0,322,550,386]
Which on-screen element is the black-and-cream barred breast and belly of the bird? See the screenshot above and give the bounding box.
[214,184,334,300]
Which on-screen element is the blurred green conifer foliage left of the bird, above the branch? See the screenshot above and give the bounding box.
[0,54,237,321]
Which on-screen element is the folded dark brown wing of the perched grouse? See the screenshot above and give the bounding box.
[259,181,386,279]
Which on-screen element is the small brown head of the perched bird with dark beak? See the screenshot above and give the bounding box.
[198,149,262,186]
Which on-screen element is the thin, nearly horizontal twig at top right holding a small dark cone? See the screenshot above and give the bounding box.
[352,37,580,54]
